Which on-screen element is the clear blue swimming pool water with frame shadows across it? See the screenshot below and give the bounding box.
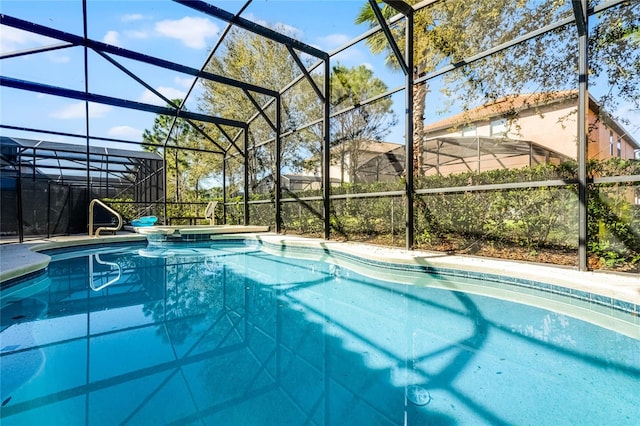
[0,243,640,426]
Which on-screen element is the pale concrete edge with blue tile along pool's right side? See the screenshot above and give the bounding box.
[245,235,640,317]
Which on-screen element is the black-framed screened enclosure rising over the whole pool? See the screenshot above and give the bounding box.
[0,0,640,273]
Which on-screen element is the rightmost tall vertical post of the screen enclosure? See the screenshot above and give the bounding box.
[572,0,589,271]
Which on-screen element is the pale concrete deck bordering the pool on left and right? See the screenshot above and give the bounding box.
[0,231,640,305]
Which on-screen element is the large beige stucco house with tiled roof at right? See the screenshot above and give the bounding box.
[423,91,640,175]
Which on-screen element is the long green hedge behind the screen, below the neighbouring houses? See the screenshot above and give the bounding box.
[283,158,640,266]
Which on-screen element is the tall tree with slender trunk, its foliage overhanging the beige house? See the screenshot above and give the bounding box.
[356,0,640,174]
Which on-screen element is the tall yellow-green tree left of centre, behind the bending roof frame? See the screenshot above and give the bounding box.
[200,27,319,194]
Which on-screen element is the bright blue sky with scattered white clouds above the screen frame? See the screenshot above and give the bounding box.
[0,0,640,149]
